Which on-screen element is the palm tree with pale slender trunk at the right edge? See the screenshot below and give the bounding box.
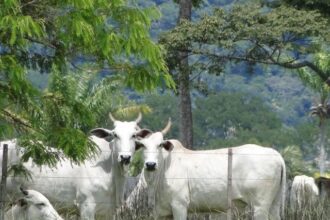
[299,53,330,176]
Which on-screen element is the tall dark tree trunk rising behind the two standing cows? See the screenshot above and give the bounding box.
[177,0,193,148]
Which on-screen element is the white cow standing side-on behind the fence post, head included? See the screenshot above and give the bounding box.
[138,121,286,220]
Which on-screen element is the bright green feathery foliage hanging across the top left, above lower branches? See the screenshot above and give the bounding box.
[0,0,173,90]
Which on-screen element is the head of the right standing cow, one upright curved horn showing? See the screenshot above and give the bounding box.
[138,119,173,171]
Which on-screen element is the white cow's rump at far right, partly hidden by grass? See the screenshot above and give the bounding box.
[290,175,319,211]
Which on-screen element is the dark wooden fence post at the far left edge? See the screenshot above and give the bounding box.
[0,144,8,220]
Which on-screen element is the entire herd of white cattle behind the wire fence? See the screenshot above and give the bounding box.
[0,114,326,220]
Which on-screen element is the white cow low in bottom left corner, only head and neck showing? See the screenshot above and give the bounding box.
[5,188,63,220]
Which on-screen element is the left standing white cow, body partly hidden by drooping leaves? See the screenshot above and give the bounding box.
[0,114,150,220]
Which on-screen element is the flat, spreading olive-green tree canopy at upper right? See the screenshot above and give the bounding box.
[160,4,329,81]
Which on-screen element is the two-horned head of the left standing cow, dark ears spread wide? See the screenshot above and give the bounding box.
[91,113,151,165]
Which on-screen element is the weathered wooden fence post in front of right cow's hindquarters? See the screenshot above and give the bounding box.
[227,148,233,220]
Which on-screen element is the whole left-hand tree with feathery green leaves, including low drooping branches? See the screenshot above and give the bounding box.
[0,0,173,164]
